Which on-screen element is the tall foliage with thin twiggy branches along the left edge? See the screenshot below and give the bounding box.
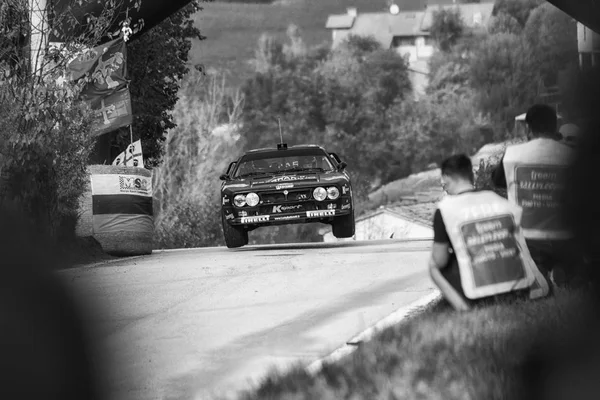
[0,0,127,238]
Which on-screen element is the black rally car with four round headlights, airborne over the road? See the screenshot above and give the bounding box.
[220,143,354,248]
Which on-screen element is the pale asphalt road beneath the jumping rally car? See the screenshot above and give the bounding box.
[61,241,433,400]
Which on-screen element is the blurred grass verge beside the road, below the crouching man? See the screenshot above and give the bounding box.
[242,291,587,400]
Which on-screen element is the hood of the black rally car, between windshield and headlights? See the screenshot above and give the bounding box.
[224,172,347,190]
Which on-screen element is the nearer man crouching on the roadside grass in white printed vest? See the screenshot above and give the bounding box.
[429,154,549,310]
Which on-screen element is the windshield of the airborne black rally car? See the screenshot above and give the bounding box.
[234,150,334,178]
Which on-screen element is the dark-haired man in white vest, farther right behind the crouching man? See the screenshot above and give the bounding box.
[493,104,586,286]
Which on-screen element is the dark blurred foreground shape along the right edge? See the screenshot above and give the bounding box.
[523,64,600,400]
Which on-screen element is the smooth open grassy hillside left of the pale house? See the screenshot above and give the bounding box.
[190,0,449,85]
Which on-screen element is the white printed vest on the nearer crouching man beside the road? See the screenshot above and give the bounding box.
[439,191,548,299]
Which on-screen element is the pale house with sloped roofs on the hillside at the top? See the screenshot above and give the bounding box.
[326,0,495,98]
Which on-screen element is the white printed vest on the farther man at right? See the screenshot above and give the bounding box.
[503,138,574,240]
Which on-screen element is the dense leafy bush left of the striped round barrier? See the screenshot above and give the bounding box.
[0,78,92,239]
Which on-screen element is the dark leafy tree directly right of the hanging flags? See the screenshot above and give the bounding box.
[110,0,205,167]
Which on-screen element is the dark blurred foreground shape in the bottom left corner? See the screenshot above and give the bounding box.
[0,204,106,400]
